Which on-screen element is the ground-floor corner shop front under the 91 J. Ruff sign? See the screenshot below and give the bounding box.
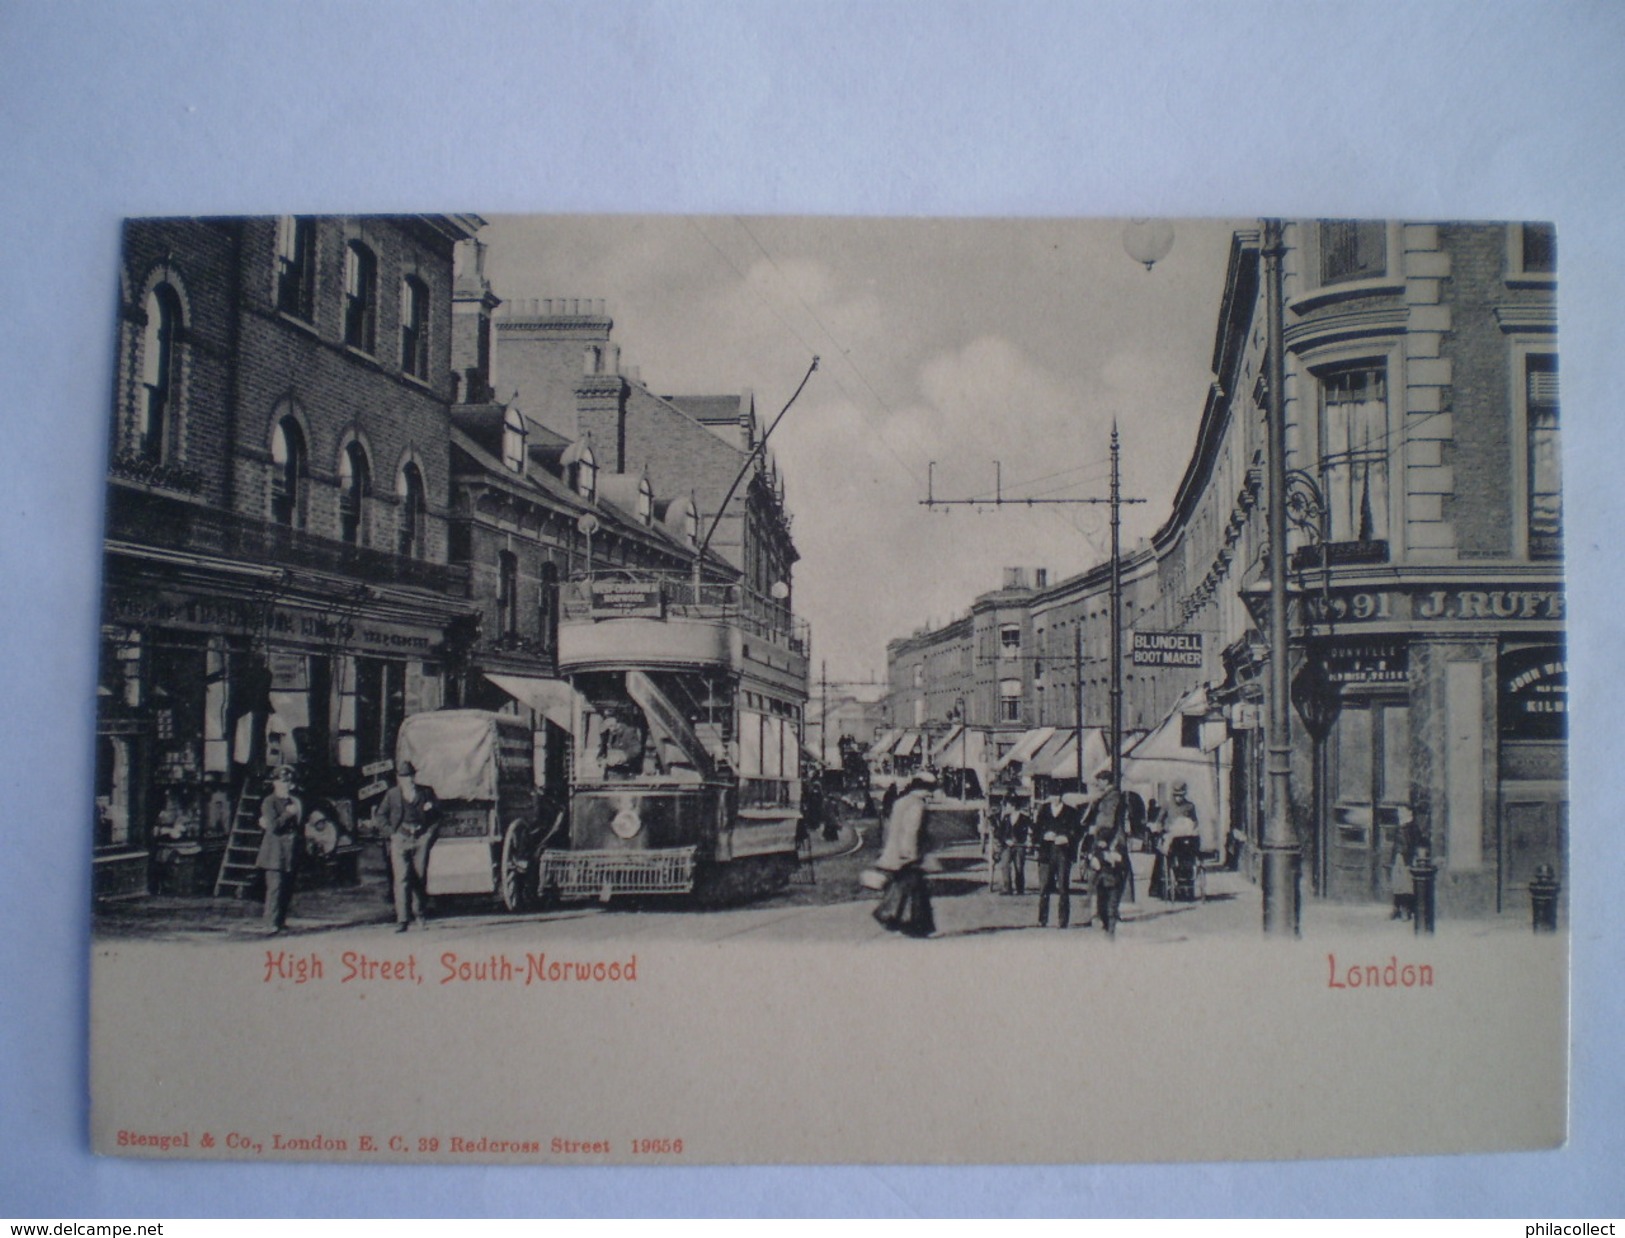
[1294,577,1568,916]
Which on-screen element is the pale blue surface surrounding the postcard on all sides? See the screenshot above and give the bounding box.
[0,0,1625,1220]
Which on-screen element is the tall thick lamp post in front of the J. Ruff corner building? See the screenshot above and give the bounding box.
[1261,219,1303,937]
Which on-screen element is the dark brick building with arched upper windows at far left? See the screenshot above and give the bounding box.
[96,216,479,894]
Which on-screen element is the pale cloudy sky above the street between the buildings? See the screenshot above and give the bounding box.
[483,216,1250,679]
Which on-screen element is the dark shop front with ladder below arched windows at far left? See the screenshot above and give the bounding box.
[94,559,471,897]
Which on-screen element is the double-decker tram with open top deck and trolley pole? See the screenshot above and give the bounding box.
[536,569,808,900]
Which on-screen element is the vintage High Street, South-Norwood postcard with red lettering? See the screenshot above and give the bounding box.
[91,214,1570,1165]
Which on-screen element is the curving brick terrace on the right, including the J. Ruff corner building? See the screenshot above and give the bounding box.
[889,221,1568,916]
